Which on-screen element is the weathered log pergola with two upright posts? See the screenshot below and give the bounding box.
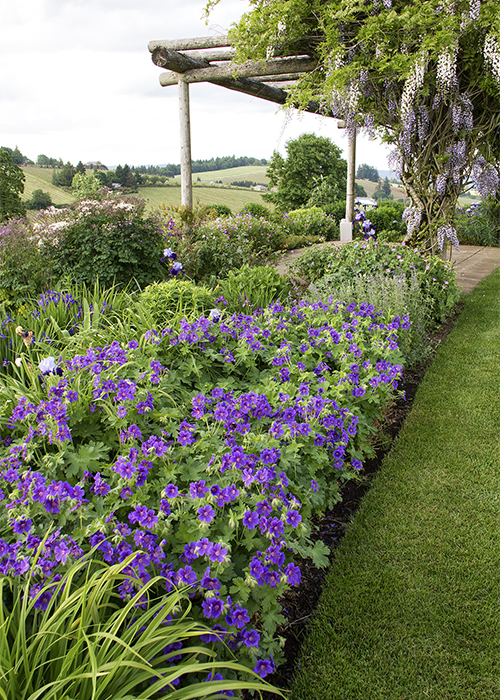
[148,35,356,240]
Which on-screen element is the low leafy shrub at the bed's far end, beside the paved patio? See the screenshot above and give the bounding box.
[292,242,460,323]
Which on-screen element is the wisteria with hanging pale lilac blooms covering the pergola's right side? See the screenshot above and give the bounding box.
[222,0,500,250]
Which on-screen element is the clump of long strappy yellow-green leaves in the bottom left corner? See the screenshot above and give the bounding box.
[0,556,281,700]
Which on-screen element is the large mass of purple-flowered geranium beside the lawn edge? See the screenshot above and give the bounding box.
[0,294,407,677]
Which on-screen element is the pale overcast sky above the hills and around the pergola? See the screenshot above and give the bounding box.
[0,0,388,170]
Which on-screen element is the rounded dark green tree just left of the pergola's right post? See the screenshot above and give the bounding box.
[262,134,347,211]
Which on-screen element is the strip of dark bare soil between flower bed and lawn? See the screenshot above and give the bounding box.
[250,306,462,700]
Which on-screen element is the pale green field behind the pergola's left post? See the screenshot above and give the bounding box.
[139,186,266,214]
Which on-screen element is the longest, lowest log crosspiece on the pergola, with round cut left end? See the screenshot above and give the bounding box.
[160,58,316,87]
